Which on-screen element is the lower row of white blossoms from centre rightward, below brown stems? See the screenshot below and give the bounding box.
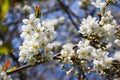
[61,39,113,70]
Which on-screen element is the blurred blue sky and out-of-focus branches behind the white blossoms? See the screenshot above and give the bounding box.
[0,0,120,80]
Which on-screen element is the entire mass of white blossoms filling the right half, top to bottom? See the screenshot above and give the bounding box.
[60,0,120,75]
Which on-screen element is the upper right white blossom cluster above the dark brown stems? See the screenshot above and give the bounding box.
[79,11,118,42]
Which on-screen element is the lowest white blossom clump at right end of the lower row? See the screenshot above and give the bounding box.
[93,49,113,71]
